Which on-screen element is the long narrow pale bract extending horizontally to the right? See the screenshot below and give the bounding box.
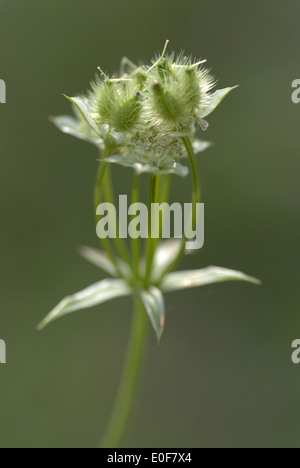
[161,267,261,292]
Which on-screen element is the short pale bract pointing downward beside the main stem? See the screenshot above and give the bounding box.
[140,286,165,341]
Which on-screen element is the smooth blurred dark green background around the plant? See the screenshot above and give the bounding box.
[0,0,300,448]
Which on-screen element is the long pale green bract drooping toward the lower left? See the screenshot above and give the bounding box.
[38,279,132,330]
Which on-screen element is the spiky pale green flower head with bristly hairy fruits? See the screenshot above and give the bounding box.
[53,41,237,175]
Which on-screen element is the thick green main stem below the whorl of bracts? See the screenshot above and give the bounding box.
[101,298,149,448]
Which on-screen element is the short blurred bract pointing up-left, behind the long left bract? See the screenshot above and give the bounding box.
[79,246,130,278]
